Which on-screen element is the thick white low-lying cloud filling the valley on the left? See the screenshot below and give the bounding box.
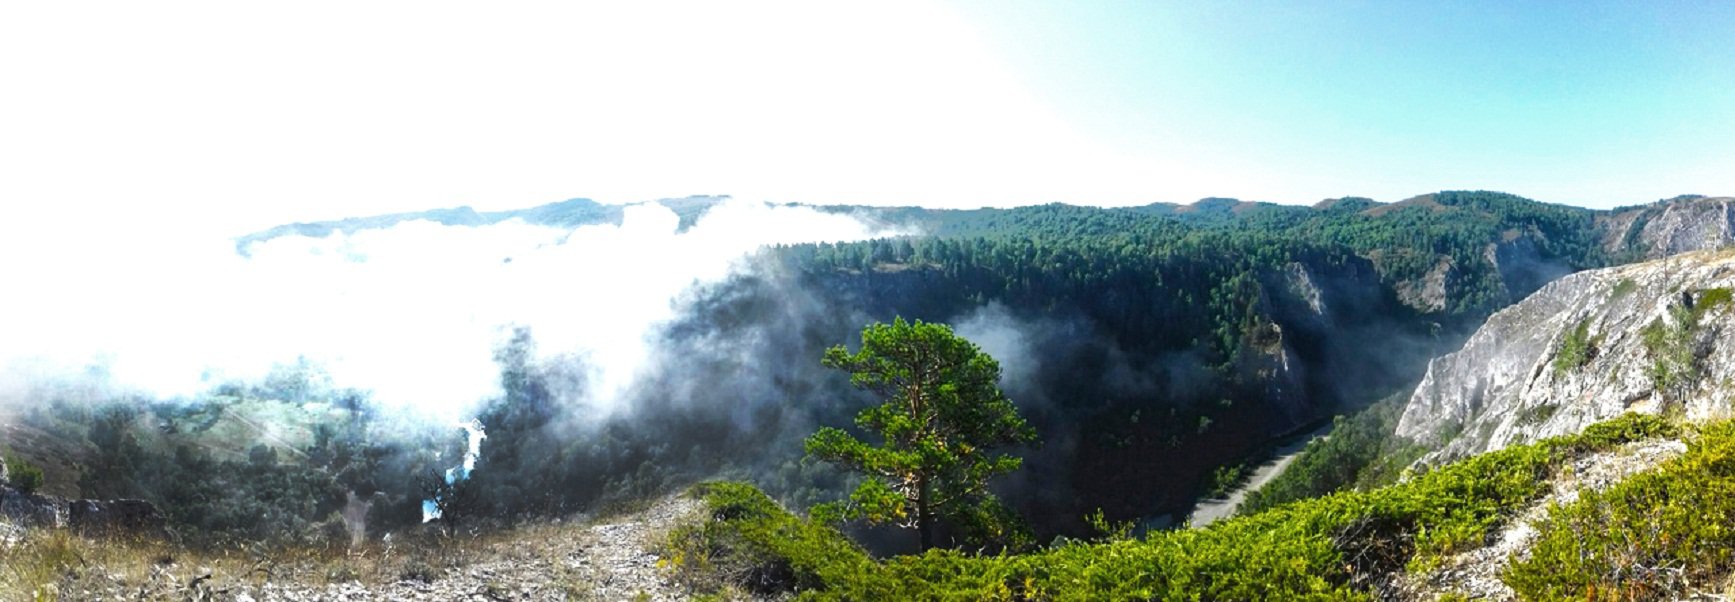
[0,201,895,420]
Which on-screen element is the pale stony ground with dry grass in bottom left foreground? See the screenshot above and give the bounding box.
[5,496,701,602]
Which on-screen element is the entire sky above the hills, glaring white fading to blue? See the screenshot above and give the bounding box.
[0,0,1735,238]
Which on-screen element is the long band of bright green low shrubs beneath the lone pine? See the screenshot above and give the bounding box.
[668,415,1679,600]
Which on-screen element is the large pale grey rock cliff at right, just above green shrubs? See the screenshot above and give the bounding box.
[1397,248,1735,463]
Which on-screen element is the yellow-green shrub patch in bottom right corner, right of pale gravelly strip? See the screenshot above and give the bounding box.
[1501,422,1735,600]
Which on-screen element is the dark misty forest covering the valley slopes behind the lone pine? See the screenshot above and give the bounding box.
[10,193,1692,543]
